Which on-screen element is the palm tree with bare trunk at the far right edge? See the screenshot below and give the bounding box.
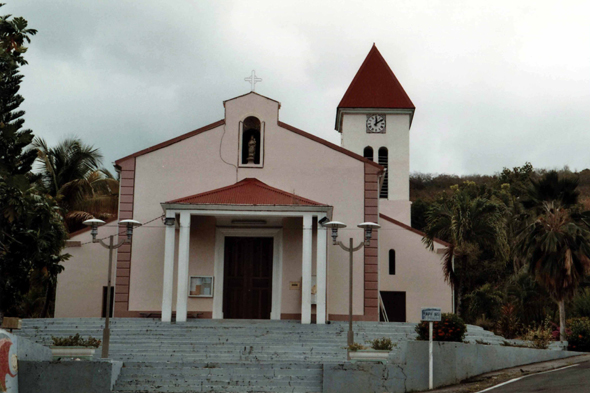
[518,201,590,341]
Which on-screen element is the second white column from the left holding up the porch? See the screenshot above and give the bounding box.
[176,211,191,322]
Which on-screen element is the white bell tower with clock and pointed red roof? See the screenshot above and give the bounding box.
[336,44,416,225]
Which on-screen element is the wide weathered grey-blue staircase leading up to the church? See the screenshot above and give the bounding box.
[19,318,508,393]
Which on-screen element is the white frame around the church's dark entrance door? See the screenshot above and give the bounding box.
[213,228,283,320]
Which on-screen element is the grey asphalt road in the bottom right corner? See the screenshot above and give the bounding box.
[486,362,590,393]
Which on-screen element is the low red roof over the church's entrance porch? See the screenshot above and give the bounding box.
[166,178,327,206]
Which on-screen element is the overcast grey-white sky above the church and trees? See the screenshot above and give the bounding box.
[5,0,590,174]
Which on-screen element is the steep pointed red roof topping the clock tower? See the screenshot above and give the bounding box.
[338,44,416,109]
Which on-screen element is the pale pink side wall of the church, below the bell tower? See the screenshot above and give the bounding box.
[379,218,452,322]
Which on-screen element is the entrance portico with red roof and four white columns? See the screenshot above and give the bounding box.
[161,179,332,324]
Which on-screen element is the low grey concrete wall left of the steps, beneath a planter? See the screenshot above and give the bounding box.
[18,360,123,393]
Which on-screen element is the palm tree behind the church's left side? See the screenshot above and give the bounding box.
[33,138,119,232]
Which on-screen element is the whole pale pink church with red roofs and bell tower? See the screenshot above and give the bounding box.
[55,46,452,324]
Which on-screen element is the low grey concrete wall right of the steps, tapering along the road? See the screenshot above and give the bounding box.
[323,341,580,393]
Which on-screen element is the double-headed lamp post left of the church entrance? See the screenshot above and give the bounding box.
[83,218,141,359]
